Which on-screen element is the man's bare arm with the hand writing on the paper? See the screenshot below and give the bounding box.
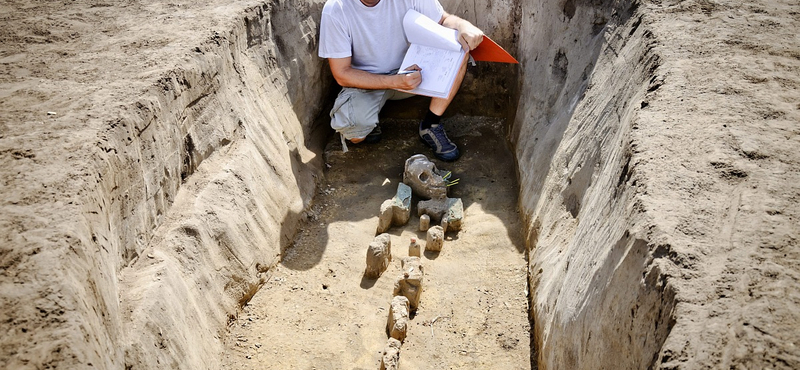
[328,57,422,90]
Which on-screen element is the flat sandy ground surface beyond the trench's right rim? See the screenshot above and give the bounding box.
[634,0,800,369]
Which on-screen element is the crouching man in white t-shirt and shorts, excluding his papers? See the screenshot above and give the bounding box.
[319,0,483,162]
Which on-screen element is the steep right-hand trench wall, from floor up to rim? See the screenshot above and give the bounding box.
[512,0,675,369]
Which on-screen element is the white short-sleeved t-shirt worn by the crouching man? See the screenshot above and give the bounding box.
[319,0,444,73]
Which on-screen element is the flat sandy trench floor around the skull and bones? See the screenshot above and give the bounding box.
[223,116,531,369]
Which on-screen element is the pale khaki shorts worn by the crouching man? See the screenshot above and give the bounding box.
[331,87,413,140]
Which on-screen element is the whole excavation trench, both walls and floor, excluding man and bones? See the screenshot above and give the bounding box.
[1,0,674,369]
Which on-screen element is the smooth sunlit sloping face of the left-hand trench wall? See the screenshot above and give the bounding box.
[114,2,329,369]
